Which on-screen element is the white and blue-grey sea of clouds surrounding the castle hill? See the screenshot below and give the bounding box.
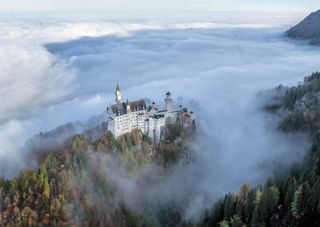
[0,10,320,215]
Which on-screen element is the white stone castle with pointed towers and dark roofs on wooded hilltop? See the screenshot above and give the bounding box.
[107,84,193,143]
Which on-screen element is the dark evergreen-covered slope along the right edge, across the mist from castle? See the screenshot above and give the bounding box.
[191,73,320,227]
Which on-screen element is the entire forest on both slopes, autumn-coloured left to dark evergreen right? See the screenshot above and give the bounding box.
[0,73,320,227]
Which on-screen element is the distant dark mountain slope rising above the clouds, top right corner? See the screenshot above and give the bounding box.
[286,10,320,45]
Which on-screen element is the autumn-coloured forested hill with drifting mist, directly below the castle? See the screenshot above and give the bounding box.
[0,116,195,227]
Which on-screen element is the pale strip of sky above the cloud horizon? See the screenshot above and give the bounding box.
[0,0,320,12]
